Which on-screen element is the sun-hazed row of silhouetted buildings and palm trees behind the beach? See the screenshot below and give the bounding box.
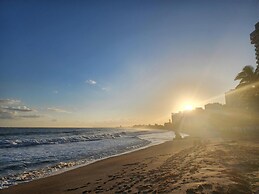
[172,22,259,138]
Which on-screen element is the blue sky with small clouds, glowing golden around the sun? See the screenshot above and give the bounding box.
[0,0,259,127]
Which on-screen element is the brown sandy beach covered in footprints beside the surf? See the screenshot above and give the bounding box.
[0,138,259,194]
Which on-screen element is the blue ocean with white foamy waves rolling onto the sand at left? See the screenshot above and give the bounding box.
[0,128,175,189]
